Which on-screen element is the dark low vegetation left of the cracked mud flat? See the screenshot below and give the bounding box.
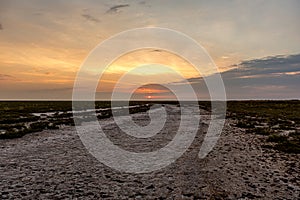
[0,101,156,139]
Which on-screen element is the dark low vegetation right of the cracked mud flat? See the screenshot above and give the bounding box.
[199,100,300,153]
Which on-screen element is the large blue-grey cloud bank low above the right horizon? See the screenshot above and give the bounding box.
[182,54,300,99]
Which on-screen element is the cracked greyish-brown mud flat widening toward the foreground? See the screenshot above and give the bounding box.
[0,106,300,199]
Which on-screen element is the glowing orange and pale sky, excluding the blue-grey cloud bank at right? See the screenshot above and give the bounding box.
[0,0,300,99]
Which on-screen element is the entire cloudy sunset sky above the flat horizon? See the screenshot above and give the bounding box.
[0,0,300,100]
